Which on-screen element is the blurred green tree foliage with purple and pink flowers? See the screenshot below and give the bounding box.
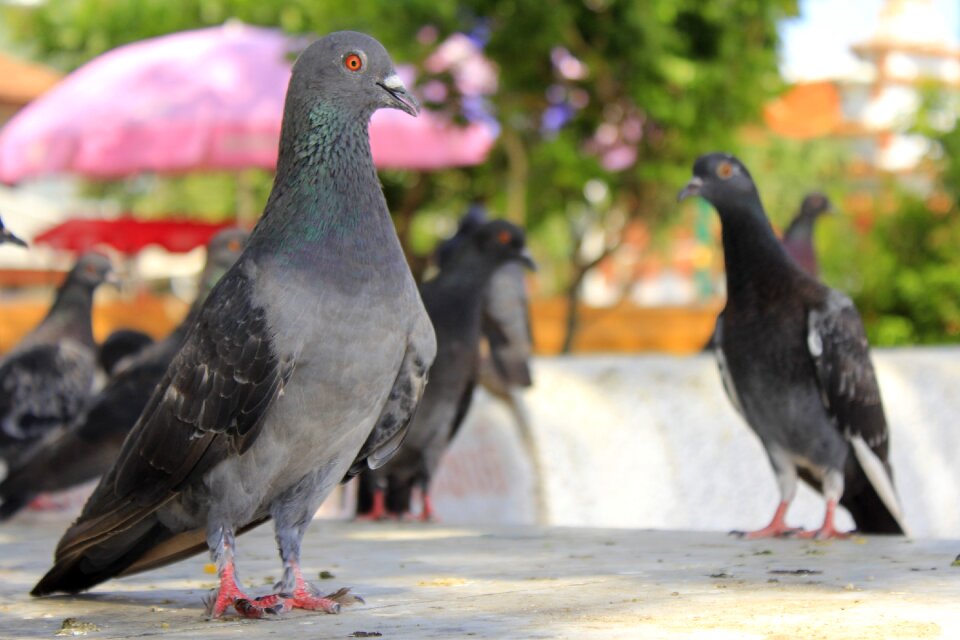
[4,0,796,348]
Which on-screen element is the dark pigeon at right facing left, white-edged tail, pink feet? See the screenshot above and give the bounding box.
[679,153,906,539]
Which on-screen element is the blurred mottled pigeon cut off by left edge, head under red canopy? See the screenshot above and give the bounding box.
[0,253,114,468]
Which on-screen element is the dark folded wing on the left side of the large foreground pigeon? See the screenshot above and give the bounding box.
[51,265,294,558]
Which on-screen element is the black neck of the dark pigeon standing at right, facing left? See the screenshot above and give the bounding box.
[718,202,796,300]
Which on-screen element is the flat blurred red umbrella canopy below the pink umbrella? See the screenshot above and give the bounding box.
[33,216,229,255]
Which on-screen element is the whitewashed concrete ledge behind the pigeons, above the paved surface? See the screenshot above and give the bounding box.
[434,348,960,536]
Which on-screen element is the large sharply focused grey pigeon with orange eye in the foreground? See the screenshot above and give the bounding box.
[32,32,436,618]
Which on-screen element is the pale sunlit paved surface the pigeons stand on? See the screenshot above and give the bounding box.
[0,517,960,640]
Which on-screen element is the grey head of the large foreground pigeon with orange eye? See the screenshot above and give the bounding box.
[288,31,420,118]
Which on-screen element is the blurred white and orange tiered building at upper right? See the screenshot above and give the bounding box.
[764,0,960,189]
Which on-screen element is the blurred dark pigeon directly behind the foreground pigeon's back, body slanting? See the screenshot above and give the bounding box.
[0,229,247,521]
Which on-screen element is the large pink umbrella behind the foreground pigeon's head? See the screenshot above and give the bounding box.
[0,23,496,183]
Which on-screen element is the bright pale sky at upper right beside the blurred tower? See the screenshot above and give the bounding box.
[781,0,960,81]
